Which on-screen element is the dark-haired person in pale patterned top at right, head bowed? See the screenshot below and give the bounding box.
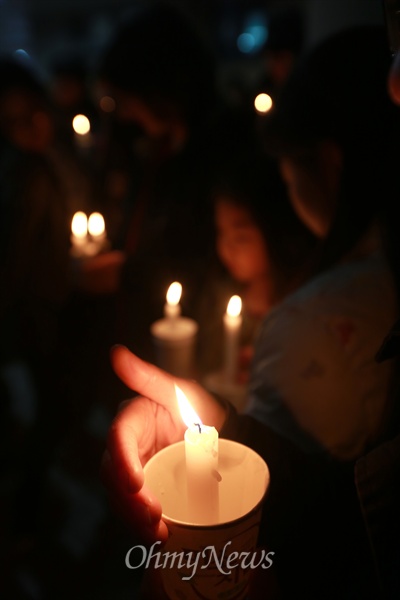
[206,28,397,459]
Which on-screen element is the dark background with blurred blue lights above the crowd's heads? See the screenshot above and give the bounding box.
[0,0,383,99]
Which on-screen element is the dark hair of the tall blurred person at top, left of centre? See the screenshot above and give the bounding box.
[99,2,215,126]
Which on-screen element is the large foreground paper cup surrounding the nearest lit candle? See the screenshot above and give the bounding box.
[144,439,272,600]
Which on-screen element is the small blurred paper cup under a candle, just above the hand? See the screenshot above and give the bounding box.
[150,317,198,378]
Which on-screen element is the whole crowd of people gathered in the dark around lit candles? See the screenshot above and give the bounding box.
[0,3,400,600]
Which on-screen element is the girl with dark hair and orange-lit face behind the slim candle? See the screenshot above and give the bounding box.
[199,112,315,383]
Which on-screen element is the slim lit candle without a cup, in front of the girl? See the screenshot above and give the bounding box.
[224,296,242,383]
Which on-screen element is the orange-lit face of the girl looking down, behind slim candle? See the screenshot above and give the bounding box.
[215,196,269,284]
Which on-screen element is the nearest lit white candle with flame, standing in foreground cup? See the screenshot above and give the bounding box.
[175,385,220,525]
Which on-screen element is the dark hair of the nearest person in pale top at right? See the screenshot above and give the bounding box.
[264,27,400,271]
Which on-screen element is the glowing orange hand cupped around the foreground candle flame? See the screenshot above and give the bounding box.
[101,346,225,543]
